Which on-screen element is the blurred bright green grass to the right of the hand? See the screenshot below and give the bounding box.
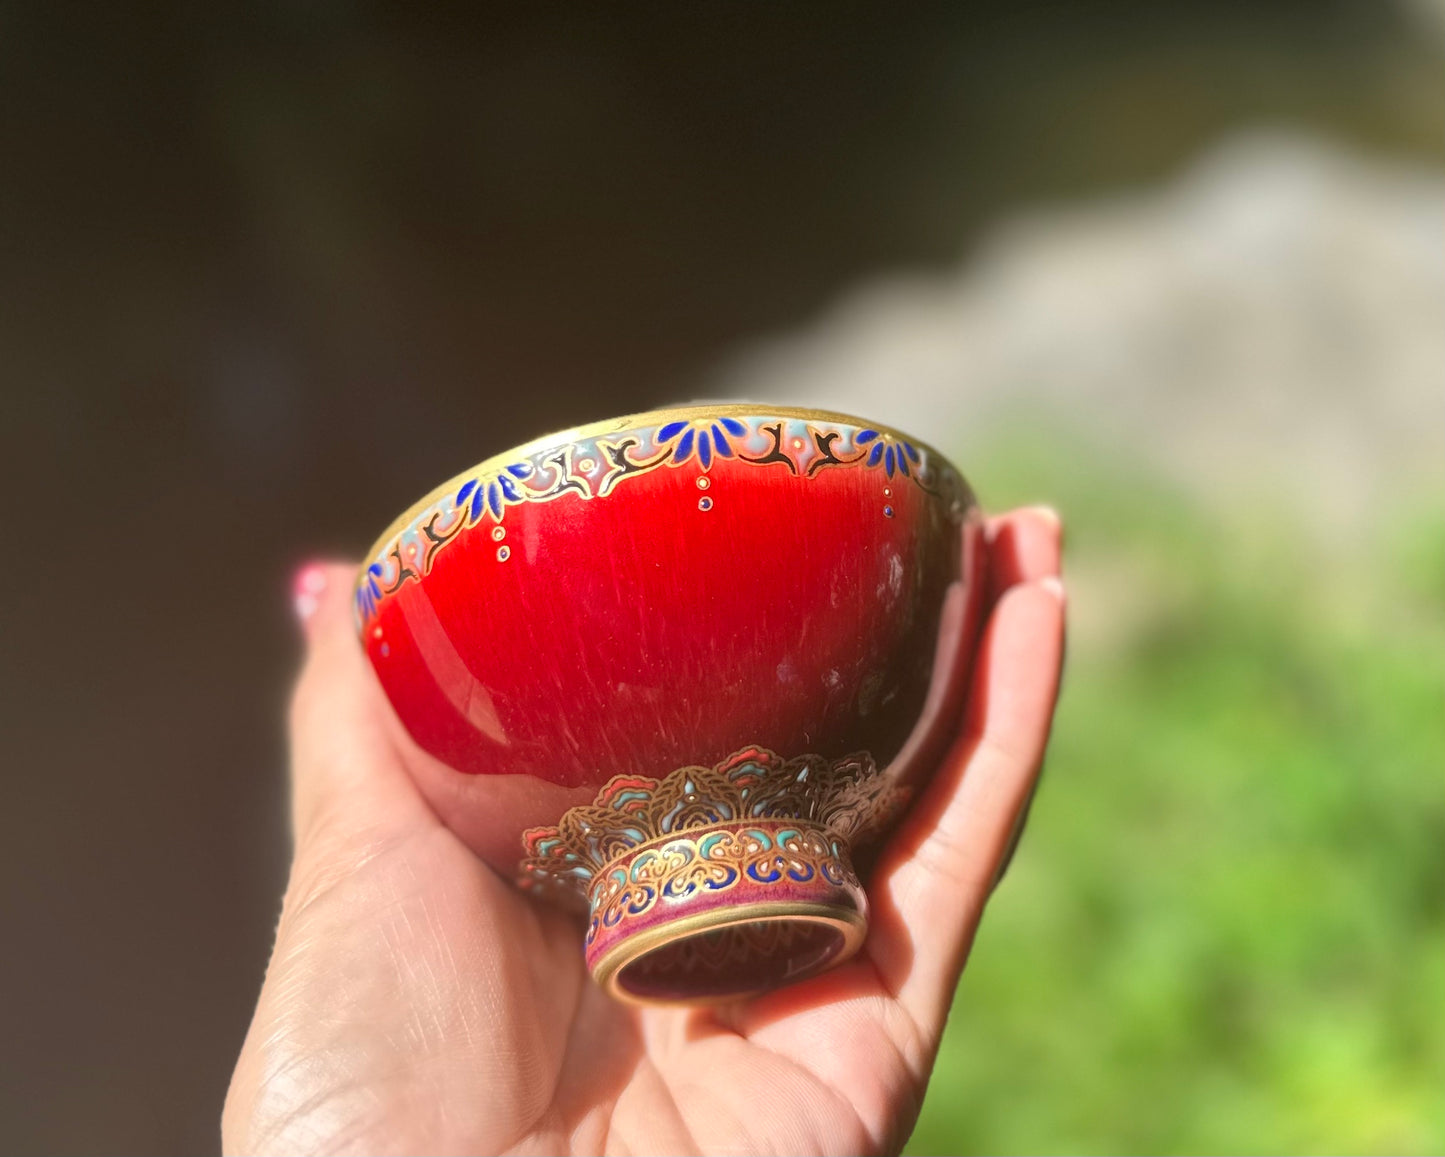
[906,438,1445,1154]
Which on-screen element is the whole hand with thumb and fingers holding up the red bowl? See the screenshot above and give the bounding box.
[224,514,1058,1153]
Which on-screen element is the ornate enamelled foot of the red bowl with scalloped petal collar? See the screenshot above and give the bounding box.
[520,747,902,1004]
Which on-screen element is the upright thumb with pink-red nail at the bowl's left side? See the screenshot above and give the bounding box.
[290,562,431,855]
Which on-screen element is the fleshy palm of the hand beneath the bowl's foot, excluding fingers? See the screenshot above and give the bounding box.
[231,751,926,1153]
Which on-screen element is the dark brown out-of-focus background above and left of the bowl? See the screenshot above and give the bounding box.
[0,0,1445,1153]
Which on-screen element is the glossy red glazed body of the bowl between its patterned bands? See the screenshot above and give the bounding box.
[361,407,980,872]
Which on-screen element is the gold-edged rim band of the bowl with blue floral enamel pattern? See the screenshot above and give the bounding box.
[355,413,968,624]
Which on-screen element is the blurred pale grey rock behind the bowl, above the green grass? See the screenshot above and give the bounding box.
[712,134,1445,529]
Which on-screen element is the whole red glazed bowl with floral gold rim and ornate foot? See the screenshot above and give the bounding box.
[355,404,981,1001]
